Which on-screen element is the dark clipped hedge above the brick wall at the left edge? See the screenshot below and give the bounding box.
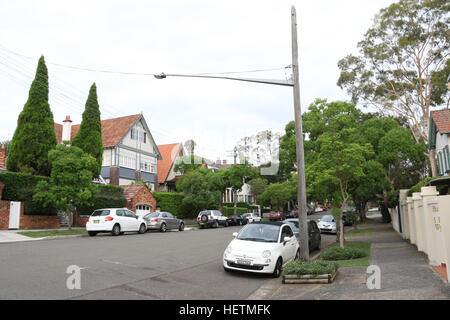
[0,171,57,215]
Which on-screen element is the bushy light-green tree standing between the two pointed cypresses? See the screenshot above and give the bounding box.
[33,144,99,230]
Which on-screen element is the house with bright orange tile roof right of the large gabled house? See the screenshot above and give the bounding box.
[158,143,185,192]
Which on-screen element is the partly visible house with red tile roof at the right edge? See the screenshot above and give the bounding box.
[428,109,450,176]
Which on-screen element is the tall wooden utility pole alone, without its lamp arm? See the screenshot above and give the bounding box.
[291,6,309,261]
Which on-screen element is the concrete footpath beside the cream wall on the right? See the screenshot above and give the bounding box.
[247,218,450,300]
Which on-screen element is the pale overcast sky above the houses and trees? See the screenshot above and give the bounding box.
[0,0,394,161]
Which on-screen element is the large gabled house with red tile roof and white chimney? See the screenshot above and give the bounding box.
[55,113,162,190]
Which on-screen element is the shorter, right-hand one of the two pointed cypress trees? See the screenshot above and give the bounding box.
[72,83,103,177]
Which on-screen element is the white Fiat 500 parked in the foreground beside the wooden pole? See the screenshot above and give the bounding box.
[223,222,299,278]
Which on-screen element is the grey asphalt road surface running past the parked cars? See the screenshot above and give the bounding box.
[0,212,335,300]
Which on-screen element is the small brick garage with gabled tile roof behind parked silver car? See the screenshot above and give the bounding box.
[121,184,156,215]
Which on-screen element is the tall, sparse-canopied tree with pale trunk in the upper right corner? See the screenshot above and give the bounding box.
[337,0,450,176]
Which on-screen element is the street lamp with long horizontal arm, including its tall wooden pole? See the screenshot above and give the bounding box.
[154,6,309,261]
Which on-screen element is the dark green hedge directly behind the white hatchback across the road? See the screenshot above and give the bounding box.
[77,184,127,215]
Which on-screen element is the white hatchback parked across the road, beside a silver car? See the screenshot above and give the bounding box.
[86,208,147,237]
